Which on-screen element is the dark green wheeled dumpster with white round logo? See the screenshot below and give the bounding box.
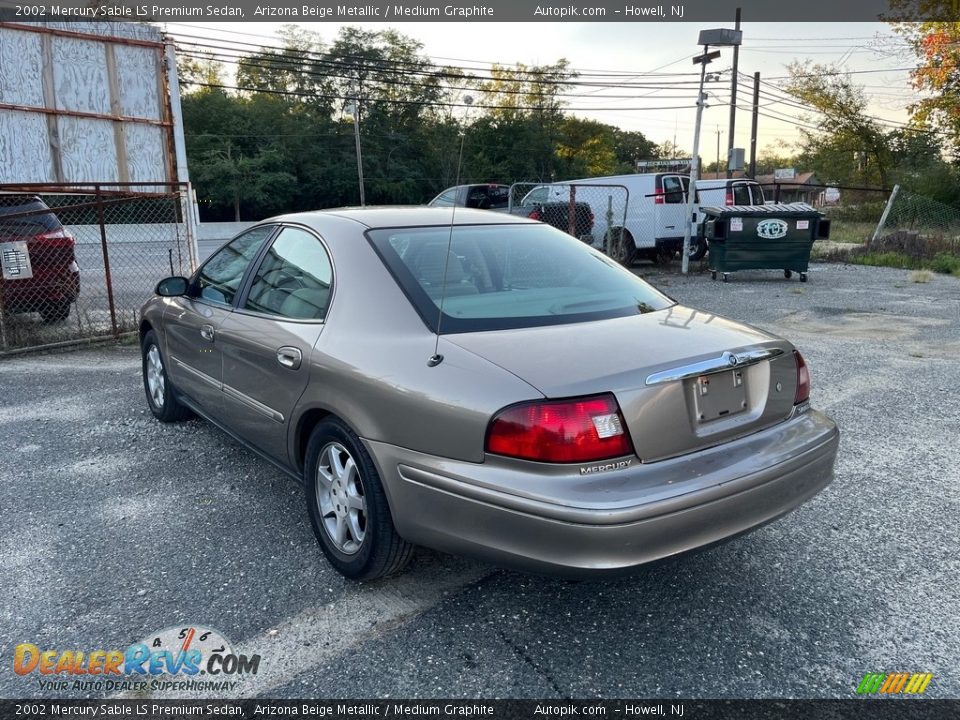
[701,203,830,282]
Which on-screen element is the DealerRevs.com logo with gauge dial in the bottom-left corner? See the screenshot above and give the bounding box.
[13,625,260,693]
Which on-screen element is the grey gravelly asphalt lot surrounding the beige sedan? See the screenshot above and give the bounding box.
[0,265,960,698]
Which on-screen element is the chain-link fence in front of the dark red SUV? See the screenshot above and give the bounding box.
[0,184,197,354]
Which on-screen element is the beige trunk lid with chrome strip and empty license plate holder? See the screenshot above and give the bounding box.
[447,306,797,462]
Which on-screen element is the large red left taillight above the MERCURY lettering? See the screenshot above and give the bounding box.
[486,394,633,463]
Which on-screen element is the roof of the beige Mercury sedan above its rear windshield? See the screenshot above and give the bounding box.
[270,205,536,228]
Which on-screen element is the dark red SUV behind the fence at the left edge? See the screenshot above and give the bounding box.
[0,194,80,322]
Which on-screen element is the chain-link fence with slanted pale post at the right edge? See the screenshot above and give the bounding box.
[868,187,960,264]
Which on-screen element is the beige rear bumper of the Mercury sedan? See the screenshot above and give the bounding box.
[367,412,839,576]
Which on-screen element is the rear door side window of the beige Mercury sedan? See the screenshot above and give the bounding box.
[243,227,333,320]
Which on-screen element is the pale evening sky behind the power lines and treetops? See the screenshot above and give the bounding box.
[166,21,916,163]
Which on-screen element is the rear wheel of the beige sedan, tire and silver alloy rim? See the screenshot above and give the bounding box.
[303,419,414,580]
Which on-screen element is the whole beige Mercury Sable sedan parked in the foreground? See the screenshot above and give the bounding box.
[141,208,839,578]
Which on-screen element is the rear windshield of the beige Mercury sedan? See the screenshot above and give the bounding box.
[368,225,673,334]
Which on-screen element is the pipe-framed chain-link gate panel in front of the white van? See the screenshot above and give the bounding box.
[510,182,630,255]
